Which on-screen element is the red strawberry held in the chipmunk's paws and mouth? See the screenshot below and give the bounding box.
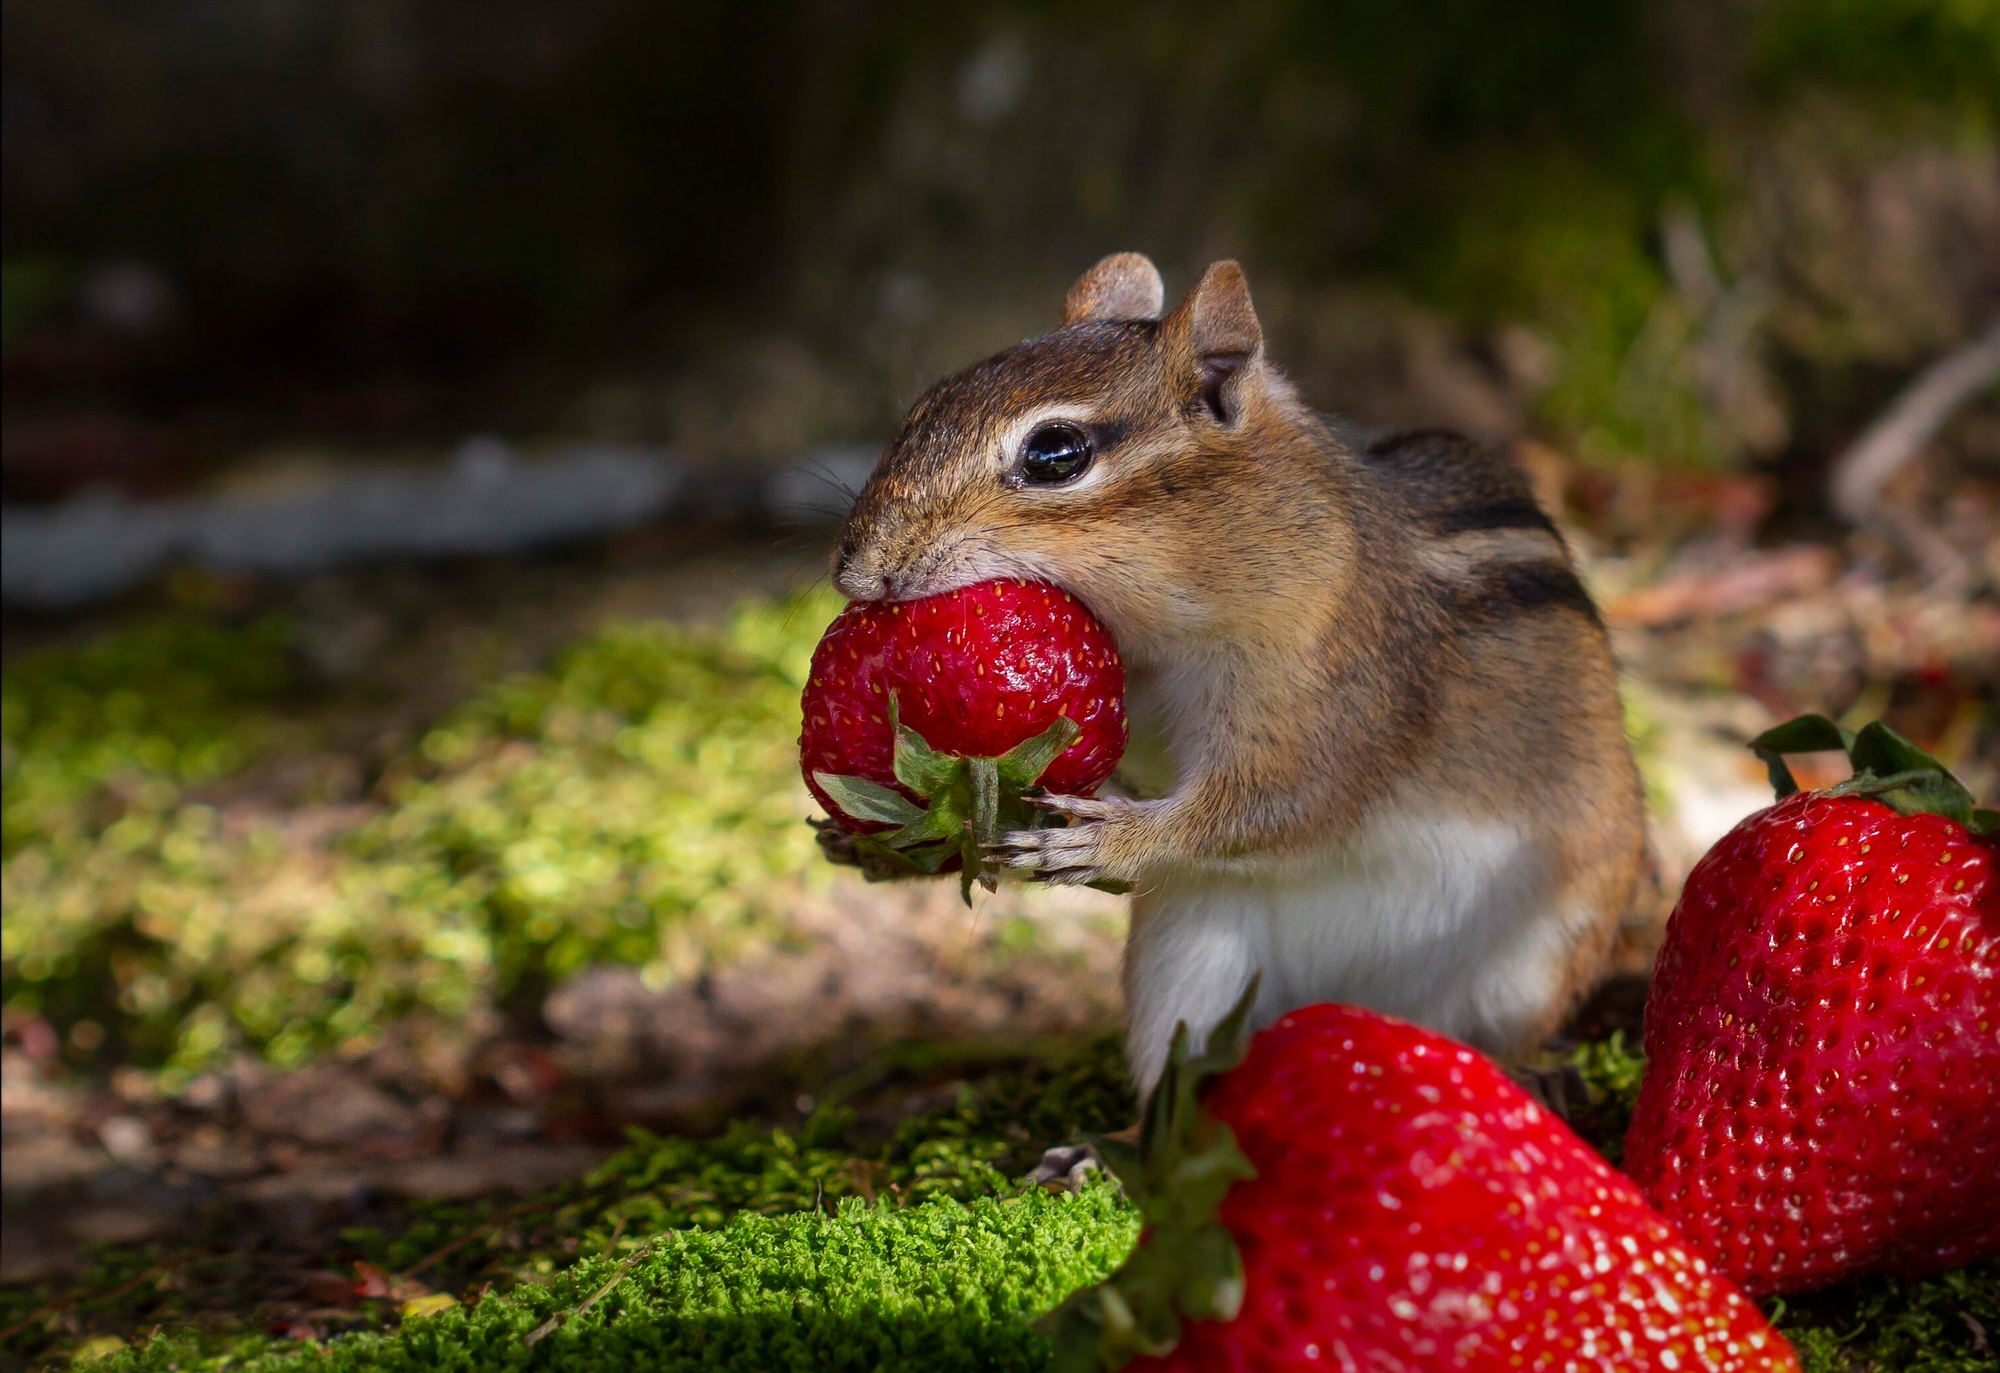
[798,580,1126,904]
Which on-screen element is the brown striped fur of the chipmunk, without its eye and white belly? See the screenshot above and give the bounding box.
[834,254,1644,1064]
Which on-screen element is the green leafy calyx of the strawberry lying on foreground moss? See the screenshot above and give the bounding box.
[1036,977,1258,1373]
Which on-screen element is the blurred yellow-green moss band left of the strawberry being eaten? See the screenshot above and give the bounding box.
[0,598,832,1073]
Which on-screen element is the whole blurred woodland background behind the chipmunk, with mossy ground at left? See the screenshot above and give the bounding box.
[0,0,2000,1312]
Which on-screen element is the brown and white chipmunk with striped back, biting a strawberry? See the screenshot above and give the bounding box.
[832,252,1646,1089]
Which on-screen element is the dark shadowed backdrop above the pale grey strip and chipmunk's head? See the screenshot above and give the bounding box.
[4,0,2000,508]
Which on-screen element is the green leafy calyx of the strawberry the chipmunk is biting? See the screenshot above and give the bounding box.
[812,693,1132,905]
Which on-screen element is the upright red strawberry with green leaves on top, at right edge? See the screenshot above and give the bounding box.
[1624,717,2000,1293]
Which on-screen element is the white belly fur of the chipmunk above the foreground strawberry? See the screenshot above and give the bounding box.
[1124,811,1588,1087]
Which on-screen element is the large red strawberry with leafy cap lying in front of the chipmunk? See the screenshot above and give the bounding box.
[1046,997,1798,1373]
